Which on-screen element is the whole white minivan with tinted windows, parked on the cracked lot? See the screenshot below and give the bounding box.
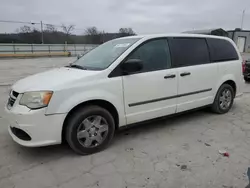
[3,34,243,154]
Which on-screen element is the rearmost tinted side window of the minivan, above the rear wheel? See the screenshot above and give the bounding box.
[207,38,239,62]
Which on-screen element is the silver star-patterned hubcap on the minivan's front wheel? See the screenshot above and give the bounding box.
[77,115,108,148]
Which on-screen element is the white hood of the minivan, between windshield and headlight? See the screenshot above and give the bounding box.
[12,67,99,93]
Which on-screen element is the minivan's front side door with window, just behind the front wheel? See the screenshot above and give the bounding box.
[123,39,177,124]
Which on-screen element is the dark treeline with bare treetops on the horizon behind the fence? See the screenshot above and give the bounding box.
[5,24,136,44]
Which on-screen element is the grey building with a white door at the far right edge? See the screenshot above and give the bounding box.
[227,28,250,53]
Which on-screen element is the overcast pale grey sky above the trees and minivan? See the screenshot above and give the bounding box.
[0,0,250,34]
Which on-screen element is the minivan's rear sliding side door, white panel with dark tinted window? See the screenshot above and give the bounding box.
[169,37,218,112]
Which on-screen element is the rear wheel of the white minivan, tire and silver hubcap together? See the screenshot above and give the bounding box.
[212,84,235,114]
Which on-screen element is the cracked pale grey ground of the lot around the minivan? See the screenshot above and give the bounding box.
[0,58,250,188]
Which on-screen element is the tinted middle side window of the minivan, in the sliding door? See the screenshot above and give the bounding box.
[169,38,210,67]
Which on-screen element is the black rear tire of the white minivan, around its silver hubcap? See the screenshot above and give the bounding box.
[212,84,235,114]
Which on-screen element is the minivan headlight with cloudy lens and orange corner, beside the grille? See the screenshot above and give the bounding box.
[19,91,53,109]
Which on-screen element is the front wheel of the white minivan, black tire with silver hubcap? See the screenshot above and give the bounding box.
[65,105,115,155]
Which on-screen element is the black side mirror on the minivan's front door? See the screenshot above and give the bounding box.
[121,59,143,74]
